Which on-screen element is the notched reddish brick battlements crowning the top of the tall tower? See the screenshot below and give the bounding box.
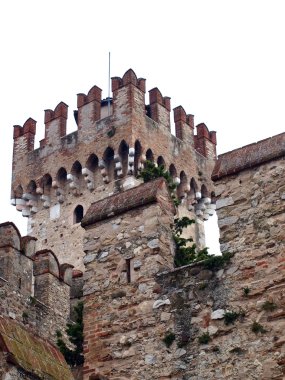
[11,69,216,160]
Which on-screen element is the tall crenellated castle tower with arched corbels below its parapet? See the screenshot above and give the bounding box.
[11,69,216,269]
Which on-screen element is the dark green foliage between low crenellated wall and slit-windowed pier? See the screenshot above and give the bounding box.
[56,302,84,367]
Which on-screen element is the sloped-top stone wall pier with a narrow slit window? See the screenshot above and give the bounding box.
[82,179,174,380]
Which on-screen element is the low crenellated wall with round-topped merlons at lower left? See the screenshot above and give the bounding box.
[0,222,79,339]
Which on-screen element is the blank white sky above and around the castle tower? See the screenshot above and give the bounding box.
[0,0,285,255]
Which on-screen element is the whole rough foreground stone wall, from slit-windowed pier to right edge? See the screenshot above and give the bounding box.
[79,133,285,380]
